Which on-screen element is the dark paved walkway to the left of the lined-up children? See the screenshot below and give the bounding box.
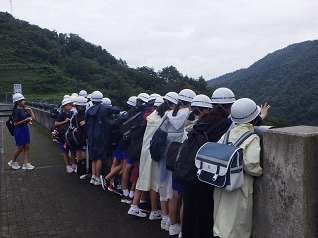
[0,118,168,238]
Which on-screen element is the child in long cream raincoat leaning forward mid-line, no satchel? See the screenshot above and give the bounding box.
[128,92,178,220]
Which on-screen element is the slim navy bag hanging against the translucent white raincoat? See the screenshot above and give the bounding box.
[149,116,168,162]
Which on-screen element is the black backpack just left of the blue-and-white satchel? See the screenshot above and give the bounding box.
[172,123,214,185]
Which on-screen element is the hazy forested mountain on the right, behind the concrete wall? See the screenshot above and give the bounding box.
[208,40,318,125]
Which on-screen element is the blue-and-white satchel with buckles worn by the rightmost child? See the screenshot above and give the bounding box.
[195,131,255,192]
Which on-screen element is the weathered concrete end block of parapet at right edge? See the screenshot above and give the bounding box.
[253,126,318,238]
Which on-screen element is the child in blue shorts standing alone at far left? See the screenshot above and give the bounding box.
[8,93,35,170]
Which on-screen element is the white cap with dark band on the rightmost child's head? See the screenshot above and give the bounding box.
[231,98,261,124]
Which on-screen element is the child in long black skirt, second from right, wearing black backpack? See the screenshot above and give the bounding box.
[182,88,235,238]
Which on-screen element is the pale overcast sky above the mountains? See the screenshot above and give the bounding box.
[0,0,318,79]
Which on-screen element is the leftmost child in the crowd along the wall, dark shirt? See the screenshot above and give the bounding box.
[54,99,76,173]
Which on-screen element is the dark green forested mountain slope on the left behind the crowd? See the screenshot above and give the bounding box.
[0,12,212,105]
